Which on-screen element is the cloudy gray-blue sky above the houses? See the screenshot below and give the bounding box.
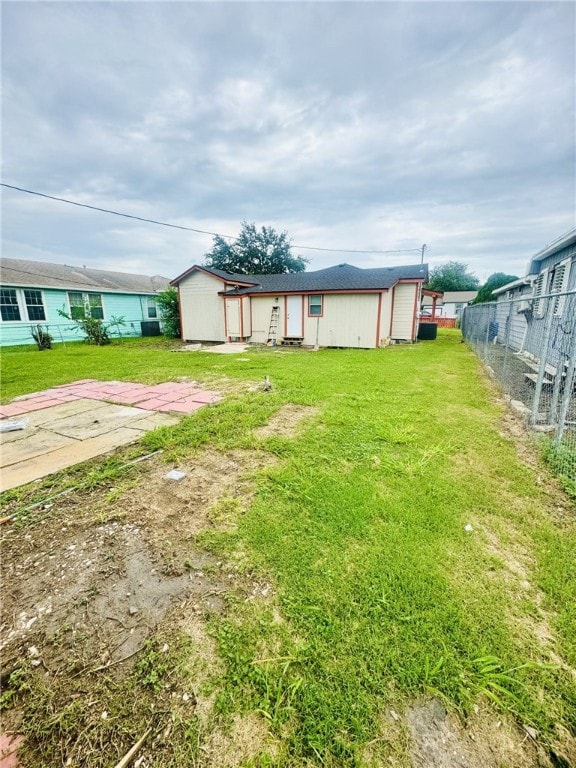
[2,0,576,280]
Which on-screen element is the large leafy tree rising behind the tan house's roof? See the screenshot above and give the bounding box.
[204,221,308,275]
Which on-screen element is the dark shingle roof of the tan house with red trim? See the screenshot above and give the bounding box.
[172,264,428,295]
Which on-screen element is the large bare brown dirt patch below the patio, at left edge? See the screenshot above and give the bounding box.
[0,518,226,670]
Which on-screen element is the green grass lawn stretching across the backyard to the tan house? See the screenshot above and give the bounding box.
[2,331,576,765]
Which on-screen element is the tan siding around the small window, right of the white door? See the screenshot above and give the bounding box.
[304,293,378,348]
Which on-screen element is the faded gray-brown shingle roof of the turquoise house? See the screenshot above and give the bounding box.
[0,258,169,293]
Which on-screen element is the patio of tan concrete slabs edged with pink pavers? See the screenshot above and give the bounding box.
[0,379,221,491]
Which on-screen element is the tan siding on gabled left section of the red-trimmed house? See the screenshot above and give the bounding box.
[180,272,226,341]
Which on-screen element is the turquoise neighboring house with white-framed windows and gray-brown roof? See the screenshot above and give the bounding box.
[0,258,169,346]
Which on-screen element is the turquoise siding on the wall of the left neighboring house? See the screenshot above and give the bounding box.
[0,284,158,346]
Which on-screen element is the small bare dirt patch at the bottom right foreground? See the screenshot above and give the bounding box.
[406,699,552,768]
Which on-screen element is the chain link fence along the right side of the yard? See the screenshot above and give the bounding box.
[461,291,576,491]
